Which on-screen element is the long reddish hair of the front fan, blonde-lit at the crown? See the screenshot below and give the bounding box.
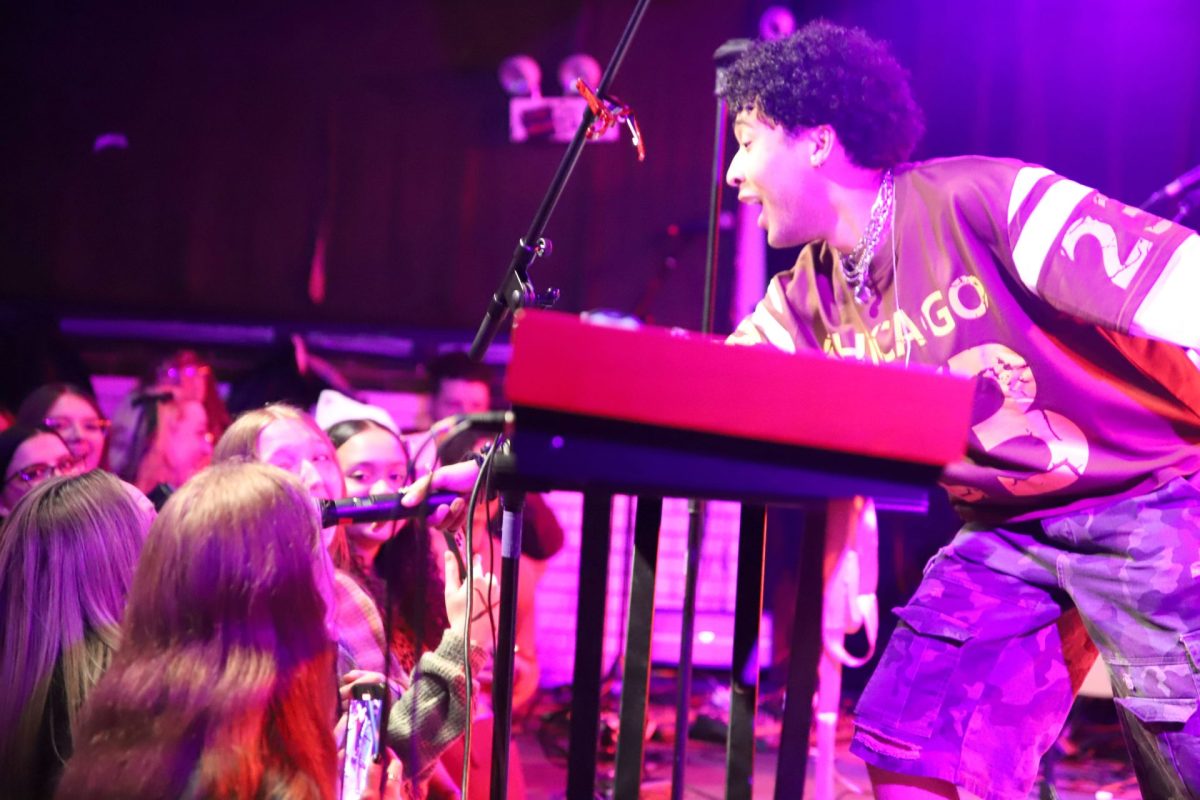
[59,463,336,799]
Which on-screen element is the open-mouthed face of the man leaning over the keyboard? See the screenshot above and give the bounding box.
[725,109,833,247]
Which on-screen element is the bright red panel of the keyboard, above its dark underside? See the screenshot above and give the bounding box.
[506,309,973,467]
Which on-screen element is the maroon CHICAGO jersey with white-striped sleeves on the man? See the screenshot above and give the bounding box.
[730,157,1200,521]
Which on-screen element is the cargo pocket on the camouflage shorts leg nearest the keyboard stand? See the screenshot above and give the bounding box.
[857,603,974,739]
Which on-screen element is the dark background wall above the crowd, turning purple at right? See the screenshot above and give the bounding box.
[0,0,1200,329]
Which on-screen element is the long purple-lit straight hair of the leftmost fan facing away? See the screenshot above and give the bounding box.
[0,470,148,798]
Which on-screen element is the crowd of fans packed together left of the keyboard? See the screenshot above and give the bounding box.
[0,353,562,799]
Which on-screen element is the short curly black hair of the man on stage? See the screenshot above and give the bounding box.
[720,19,925,169]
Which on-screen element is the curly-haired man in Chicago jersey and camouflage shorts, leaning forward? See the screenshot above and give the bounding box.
[722,22,1200,799]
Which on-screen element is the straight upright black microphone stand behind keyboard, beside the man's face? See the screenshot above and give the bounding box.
[671,38,751,800]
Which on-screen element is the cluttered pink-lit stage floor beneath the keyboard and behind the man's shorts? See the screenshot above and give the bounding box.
[515,692,1141,800]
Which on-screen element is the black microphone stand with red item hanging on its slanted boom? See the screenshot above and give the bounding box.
[467,0,650,800]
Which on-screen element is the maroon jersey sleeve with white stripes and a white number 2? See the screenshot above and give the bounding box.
[1007,166,1200,348]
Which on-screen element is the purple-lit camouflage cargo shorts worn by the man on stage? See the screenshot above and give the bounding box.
[852,476,1200,800]
